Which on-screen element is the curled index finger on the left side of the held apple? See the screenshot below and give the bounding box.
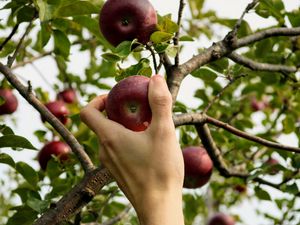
[80,95,120,137]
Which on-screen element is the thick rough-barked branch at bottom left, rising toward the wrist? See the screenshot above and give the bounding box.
[33,168,112,225]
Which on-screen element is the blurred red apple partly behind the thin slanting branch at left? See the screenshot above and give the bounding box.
[42,101,69,124]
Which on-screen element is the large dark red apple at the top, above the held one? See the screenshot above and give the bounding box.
[99,0,157,46]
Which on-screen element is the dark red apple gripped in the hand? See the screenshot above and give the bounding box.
[105,75,152,131]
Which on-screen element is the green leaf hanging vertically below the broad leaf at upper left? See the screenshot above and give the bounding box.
[53,30,71,59]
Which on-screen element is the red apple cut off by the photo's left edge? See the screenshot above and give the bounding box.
[0,89,19,115]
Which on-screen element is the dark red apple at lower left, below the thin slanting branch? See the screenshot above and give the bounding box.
[38,141,71,170]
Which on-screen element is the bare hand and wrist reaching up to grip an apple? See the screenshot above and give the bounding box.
[81,75,184,225]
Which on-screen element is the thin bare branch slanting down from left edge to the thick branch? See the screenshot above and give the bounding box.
[0,63,94,172]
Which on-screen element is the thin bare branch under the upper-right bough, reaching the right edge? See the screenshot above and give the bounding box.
[227,52,298,73]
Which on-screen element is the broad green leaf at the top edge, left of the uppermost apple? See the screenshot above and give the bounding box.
[55,1,99,17]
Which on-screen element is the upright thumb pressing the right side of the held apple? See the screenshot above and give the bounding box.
[148,75,172,124]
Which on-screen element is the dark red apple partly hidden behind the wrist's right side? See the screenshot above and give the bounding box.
[182,146,213,188]
